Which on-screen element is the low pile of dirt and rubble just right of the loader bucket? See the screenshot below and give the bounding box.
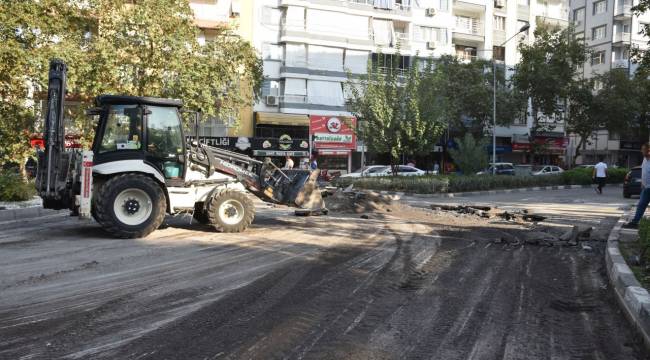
[324,189,399,214]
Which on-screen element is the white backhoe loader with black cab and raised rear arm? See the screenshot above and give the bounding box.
[36,60,327,238]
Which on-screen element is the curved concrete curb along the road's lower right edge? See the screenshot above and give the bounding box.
[605,213,650,350]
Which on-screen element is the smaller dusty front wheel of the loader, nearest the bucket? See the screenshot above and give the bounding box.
[206,189,255,232]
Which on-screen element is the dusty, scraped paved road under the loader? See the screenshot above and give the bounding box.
[0,189,648,360]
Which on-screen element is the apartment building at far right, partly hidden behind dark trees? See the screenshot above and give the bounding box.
[568,0,650,166]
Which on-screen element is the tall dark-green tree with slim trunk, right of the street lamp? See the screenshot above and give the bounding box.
[512,26,586,161]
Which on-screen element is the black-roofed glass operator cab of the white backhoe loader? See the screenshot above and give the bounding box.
[93,95,185,186]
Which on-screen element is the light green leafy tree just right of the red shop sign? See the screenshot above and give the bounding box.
[345,54,444,169]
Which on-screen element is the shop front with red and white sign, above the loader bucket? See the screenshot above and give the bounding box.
[309,115,357,173]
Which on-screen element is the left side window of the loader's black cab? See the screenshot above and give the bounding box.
[99,105,142,153]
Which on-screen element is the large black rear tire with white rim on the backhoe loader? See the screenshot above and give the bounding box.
[95,173,167,239]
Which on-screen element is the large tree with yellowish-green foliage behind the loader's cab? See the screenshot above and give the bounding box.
[0,0,263,174]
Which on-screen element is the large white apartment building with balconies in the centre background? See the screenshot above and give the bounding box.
[248,0,569,170]
